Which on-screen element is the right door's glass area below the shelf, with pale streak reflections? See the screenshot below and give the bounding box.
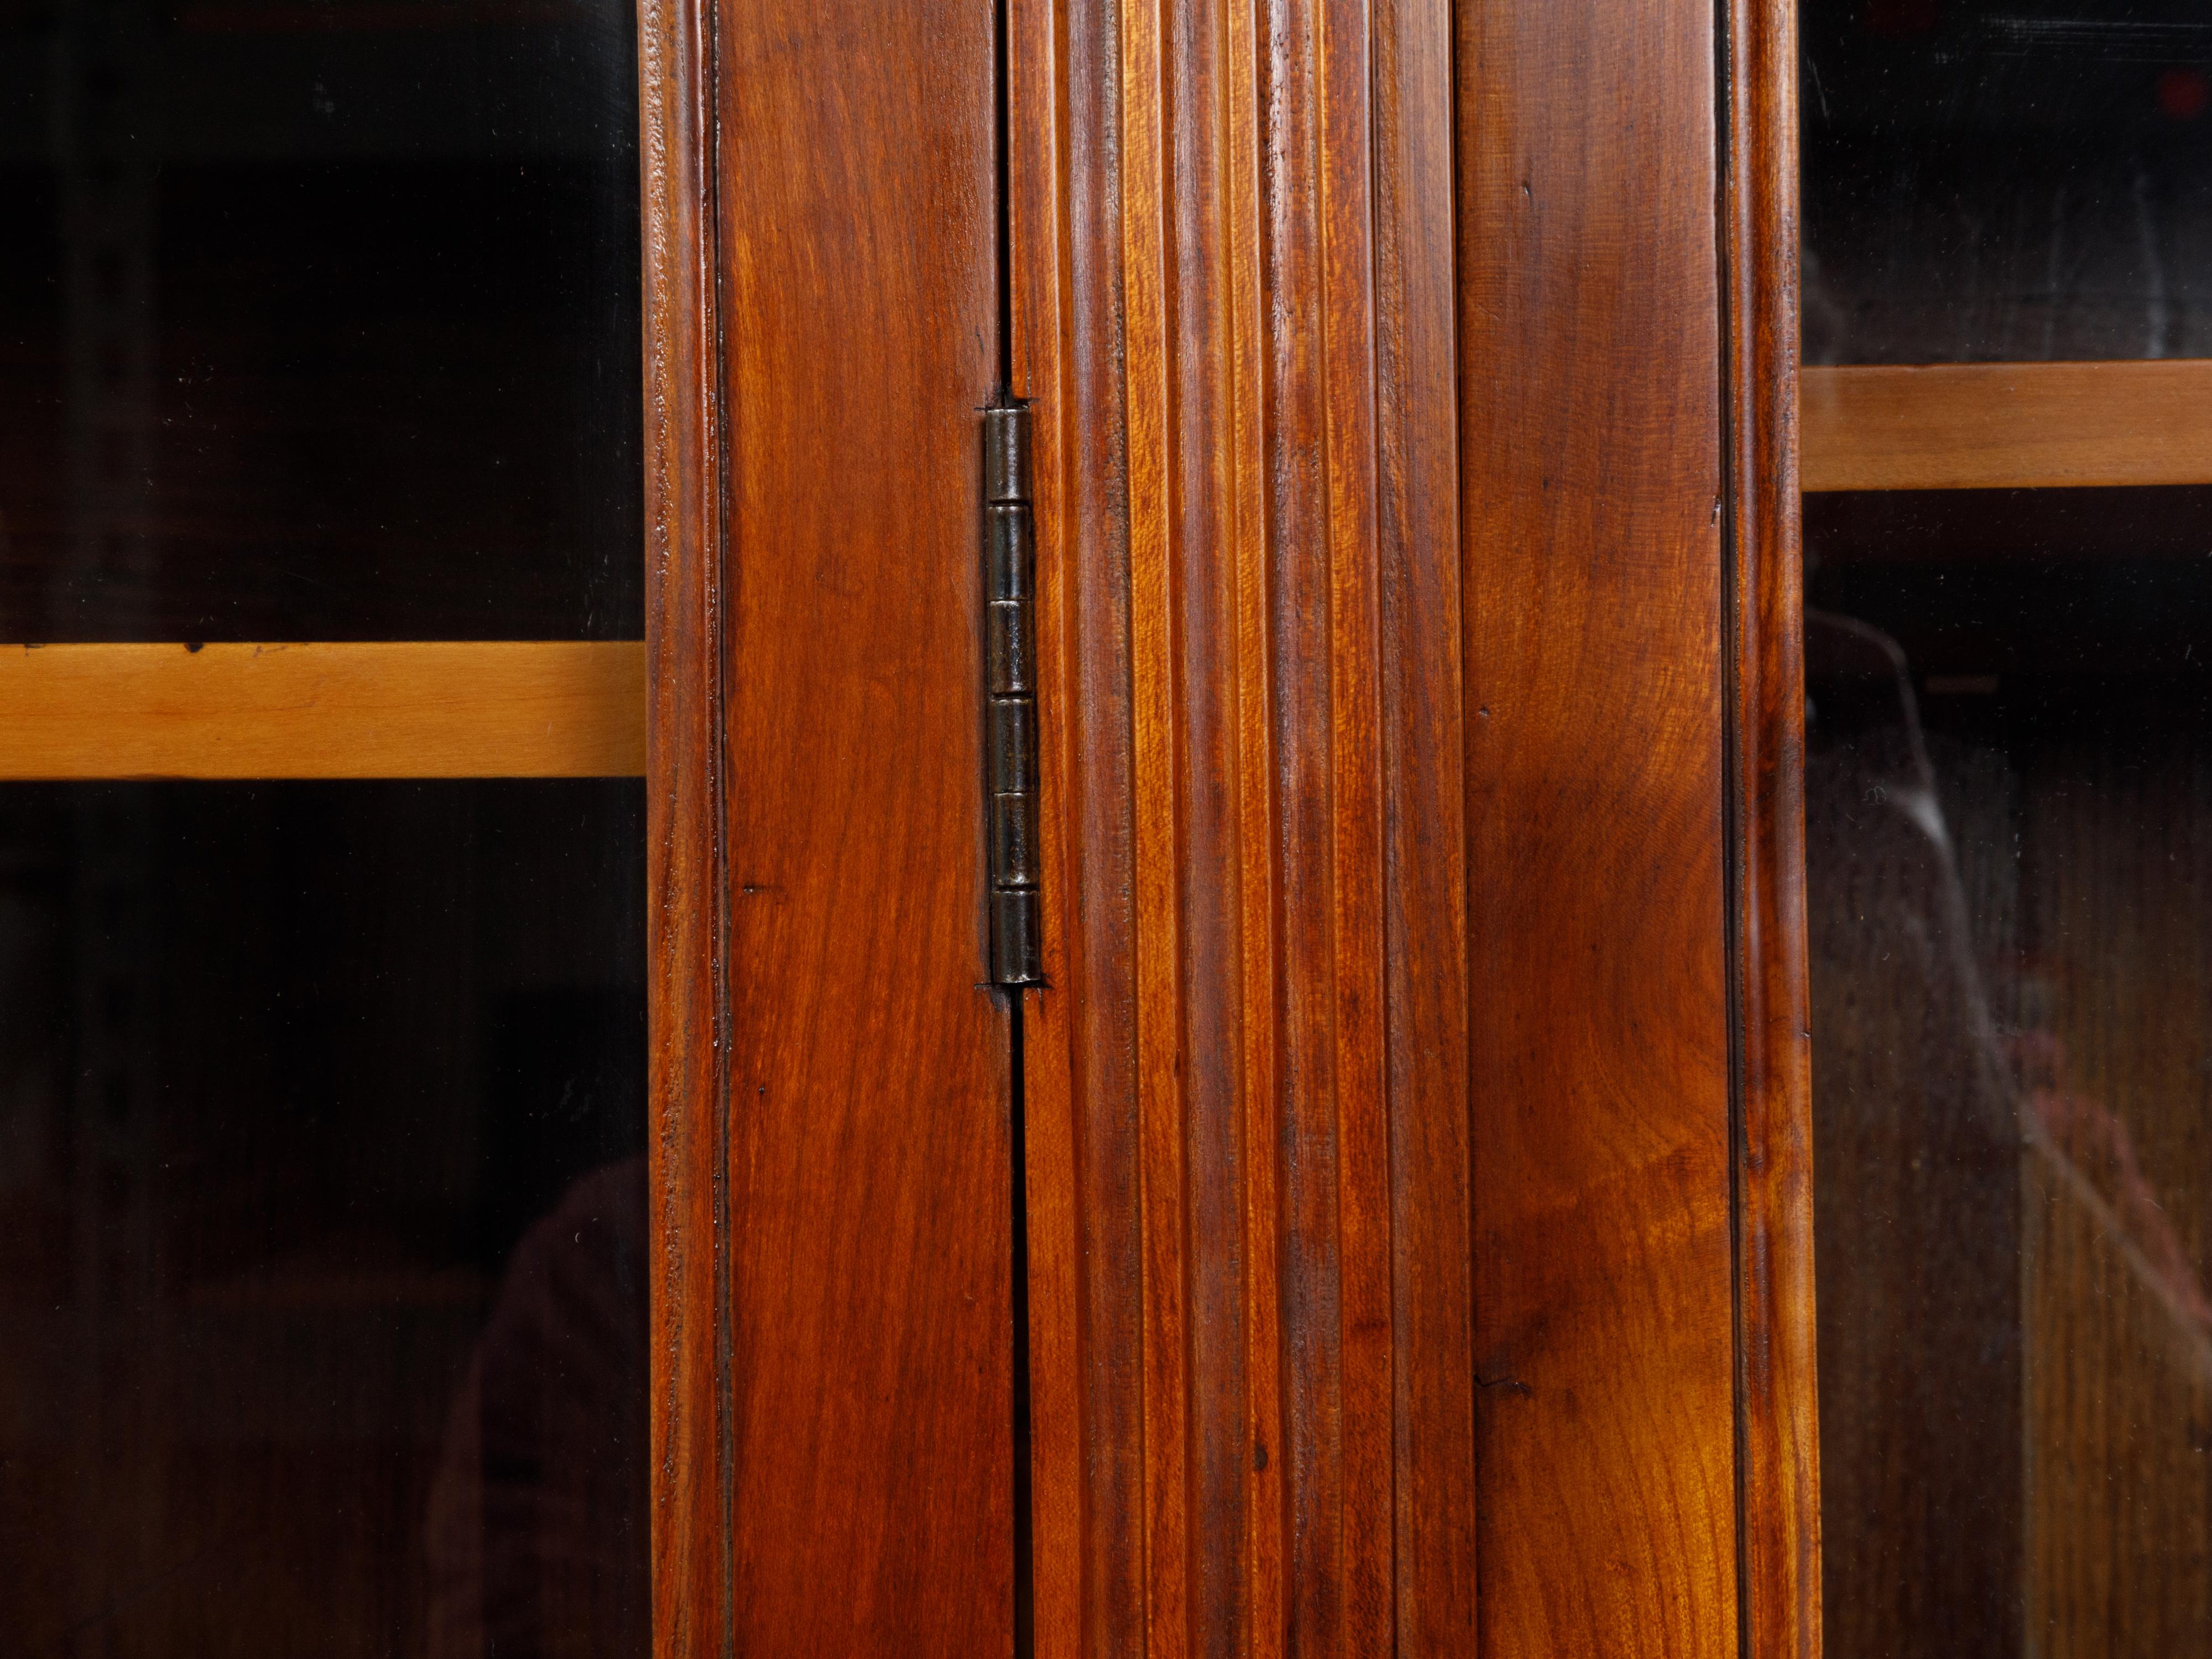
[1807,491,2212,1655]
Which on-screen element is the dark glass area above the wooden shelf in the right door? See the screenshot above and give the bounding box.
[1801,0,2212,363]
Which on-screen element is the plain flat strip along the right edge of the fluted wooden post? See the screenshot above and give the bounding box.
[1374,0,1480,1655]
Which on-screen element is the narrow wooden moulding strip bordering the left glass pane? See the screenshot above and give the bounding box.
[637,0,737,1659]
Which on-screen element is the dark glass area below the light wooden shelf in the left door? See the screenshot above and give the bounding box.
[0,781,648,1659]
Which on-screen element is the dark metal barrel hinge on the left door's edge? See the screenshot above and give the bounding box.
[982,392,1044,984]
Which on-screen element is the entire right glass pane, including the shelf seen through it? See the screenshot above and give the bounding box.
[1801,0,2212,1659]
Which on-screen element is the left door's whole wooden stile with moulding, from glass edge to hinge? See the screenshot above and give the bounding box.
[646,0,1013,1659]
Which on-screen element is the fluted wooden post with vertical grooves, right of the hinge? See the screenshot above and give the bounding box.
[1011,0,1475,1655]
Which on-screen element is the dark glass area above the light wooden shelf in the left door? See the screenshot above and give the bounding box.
[0,0,641,641]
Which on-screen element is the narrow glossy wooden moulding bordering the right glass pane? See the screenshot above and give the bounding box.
[1721,0,1820,1659]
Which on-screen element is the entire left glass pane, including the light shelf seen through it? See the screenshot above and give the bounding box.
[0,0,650,1659]
